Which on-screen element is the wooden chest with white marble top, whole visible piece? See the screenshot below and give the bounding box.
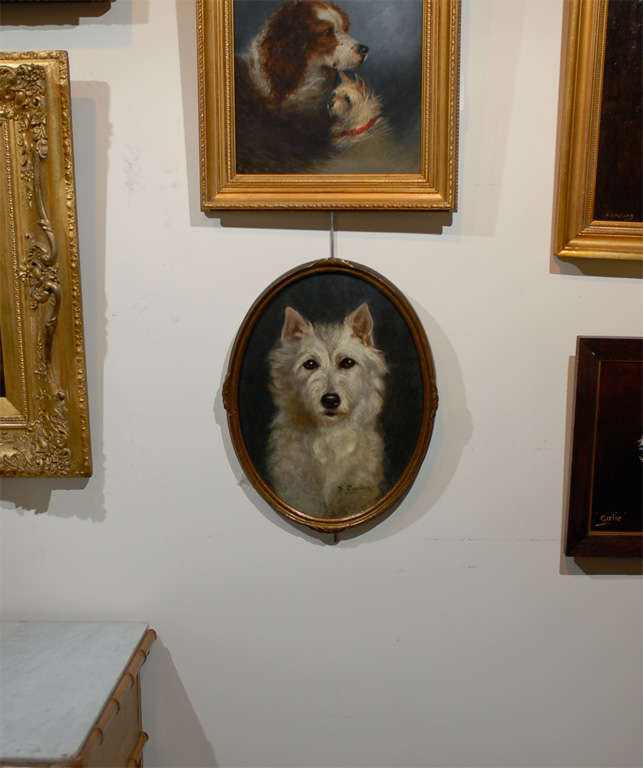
[0,622,156,768]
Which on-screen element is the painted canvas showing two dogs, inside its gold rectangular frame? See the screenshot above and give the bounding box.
[234,0,423,173]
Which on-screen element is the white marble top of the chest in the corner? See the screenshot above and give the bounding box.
[0,621,147,762]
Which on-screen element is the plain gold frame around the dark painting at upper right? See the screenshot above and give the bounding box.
[553,0,643,260]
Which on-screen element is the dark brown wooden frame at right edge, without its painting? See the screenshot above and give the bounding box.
[565,337,643,557]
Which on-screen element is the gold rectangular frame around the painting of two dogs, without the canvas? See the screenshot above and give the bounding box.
[197,0,460,211]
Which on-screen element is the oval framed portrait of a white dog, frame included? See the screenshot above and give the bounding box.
[224,260,437,530]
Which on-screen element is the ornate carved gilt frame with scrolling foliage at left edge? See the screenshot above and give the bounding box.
[0,51,92,477]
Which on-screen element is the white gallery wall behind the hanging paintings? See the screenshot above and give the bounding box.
[0,0,643,768]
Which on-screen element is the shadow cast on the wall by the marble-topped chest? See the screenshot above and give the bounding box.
[141,640,219,768]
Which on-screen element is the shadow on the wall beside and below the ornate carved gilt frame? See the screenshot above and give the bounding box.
[0,87,109,522]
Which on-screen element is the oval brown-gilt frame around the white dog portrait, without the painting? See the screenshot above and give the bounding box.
[223,258,438,532]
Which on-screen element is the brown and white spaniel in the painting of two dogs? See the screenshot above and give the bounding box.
[235,0,368,173]
